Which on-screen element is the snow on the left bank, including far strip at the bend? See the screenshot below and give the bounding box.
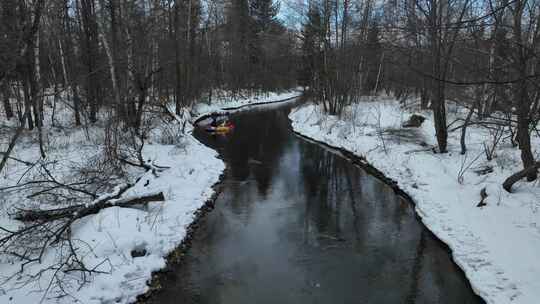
[0,90,301,303]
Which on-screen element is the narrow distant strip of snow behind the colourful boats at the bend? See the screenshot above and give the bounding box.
[192,87,303,120]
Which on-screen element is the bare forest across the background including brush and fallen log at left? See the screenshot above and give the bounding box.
[0,0,540,297]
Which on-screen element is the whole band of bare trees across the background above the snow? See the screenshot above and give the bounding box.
[4,0,540,190]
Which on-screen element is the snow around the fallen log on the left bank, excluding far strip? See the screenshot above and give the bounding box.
[0,108,225,303]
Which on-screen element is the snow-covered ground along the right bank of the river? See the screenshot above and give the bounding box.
[289,97,540,304]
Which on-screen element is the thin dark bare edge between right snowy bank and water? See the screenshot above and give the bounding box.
[289,129,488,303]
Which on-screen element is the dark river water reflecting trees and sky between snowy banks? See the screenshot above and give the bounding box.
[153,106,483,304]
